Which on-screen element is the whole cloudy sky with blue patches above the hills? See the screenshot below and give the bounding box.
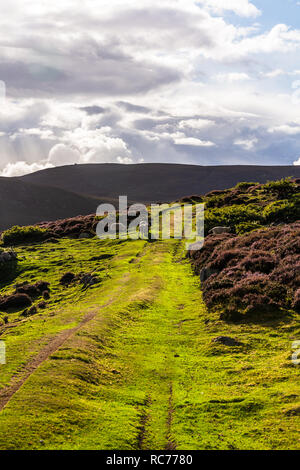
[0,0,300,176]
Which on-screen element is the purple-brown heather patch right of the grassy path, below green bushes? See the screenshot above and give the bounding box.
[191,222,300,321]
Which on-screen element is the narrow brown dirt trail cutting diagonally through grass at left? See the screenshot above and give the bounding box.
[0,275,128,412]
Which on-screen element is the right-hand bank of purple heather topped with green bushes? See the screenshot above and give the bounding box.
[190,180,300,321]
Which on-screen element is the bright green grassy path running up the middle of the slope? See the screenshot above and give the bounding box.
[73,244,203,449]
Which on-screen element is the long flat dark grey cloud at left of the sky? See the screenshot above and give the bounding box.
[0,50,182,97]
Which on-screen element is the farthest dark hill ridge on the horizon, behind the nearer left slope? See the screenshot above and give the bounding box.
[20,163,300,202]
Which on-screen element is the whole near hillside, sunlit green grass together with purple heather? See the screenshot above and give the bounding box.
[0,181,300,451]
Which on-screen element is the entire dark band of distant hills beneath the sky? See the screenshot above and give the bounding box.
[0,163,300,230]
